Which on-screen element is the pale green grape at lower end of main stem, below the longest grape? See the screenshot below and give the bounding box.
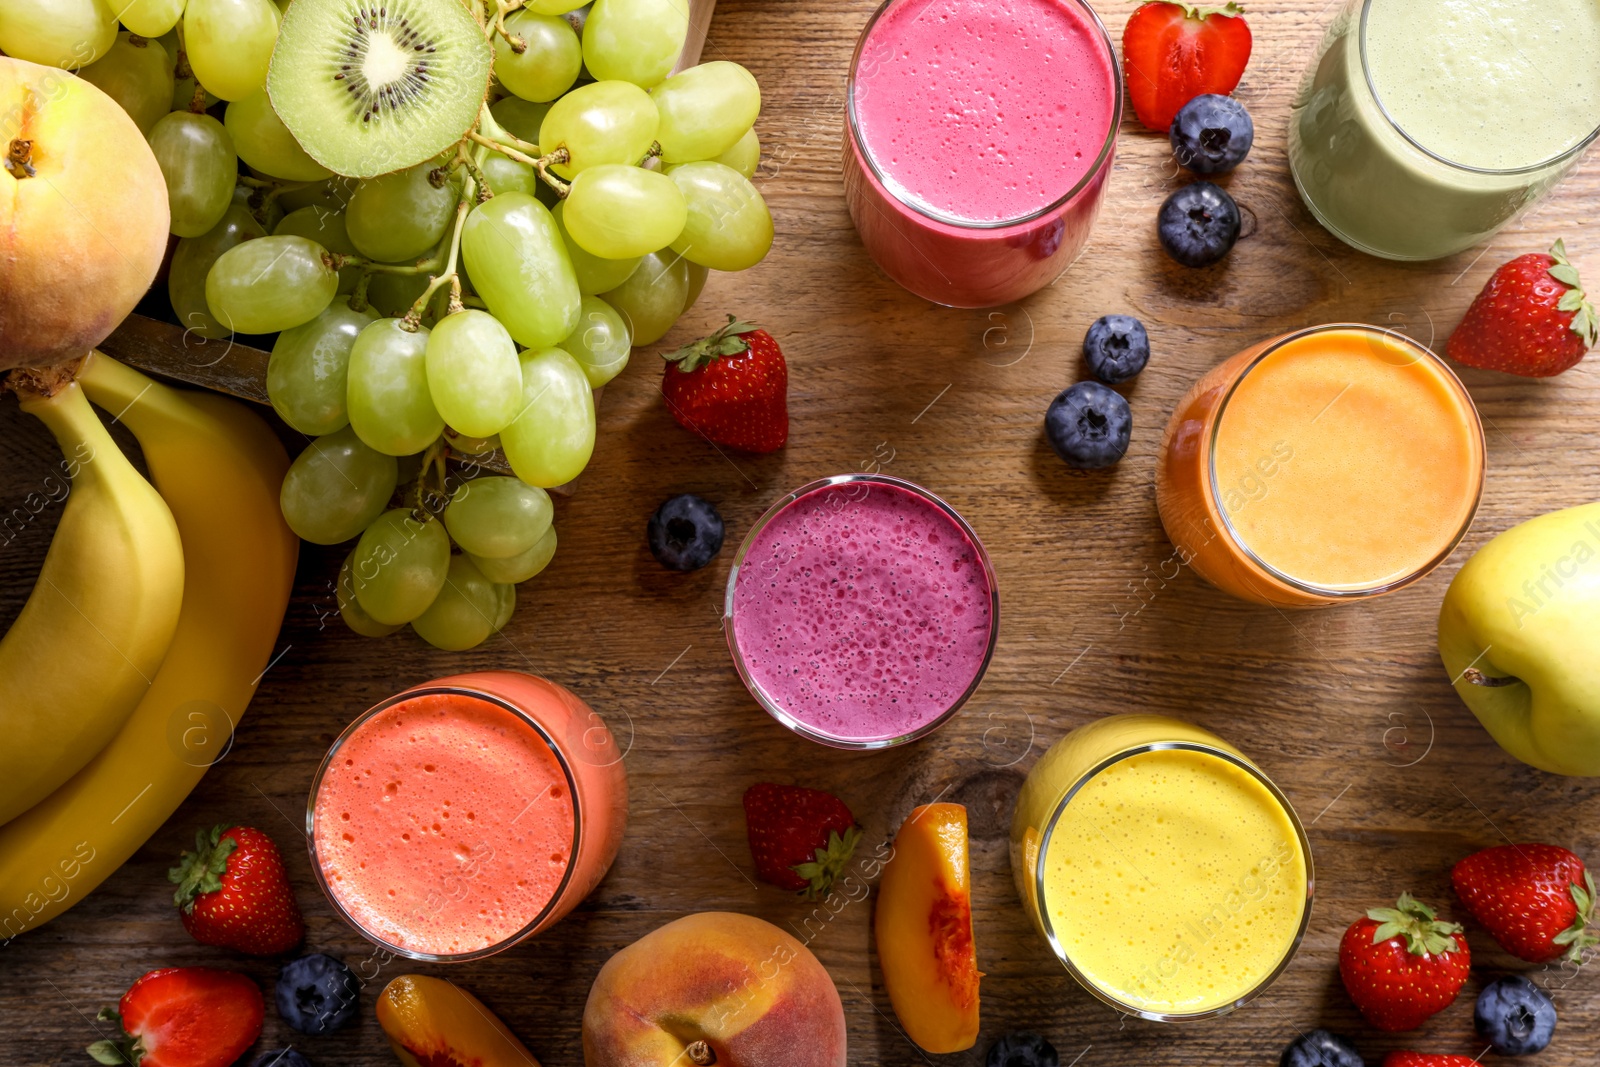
[427,310,523,437]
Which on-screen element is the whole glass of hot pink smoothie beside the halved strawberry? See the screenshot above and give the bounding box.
[845,0,1122,307]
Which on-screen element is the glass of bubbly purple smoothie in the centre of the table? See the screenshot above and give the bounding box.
[723,475,998,749]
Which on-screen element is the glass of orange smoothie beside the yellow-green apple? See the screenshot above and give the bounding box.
[1155,325,1483,606]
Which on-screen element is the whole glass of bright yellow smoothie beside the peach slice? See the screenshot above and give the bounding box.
[1013,715,1312,1021]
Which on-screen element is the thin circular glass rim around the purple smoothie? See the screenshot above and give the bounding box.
[722,474,1000,752]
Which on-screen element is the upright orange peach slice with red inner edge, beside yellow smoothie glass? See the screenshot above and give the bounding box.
[874,805,982,1053]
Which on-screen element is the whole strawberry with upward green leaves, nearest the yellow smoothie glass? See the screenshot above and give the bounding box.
[1339,893,1472,1030]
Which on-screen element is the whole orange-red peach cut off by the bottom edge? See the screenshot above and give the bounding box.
[584,912,845,1067]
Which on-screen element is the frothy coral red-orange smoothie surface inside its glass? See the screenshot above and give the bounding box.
[315,694,573,955]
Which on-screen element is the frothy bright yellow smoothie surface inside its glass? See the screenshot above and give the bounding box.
[1045,749,1306,1014]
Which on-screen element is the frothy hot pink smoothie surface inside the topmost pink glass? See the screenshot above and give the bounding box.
[854,0,1117,222]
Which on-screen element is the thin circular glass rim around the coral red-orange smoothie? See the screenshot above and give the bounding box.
[306,685,584,963]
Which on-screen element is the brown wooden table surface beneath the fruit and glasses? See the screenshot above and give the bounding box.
[0,0,1600,1067]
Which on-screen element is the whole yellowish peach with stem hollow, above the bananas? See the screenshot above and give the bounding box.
[0,58,168,371]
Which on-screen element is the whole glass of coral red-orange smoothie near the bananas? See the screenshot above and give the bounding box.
[307,672,627,961]
